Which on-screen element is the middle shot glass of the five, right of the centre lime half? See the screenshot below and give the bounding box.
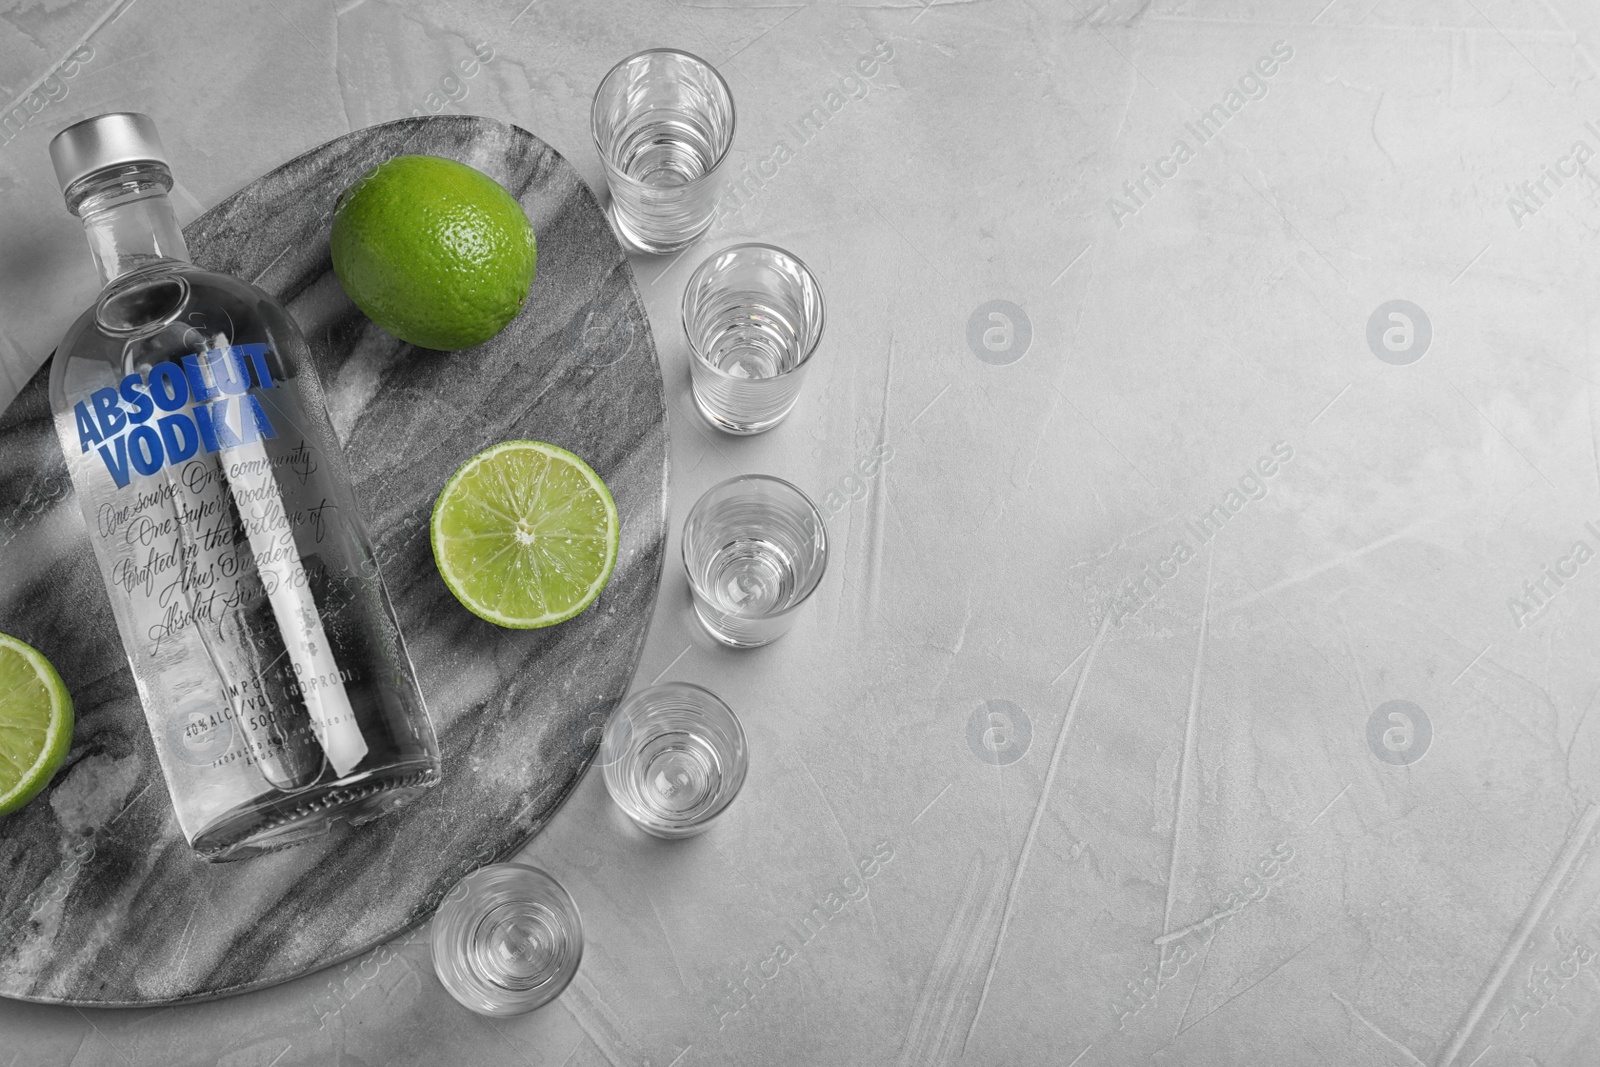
[683,475,827,648]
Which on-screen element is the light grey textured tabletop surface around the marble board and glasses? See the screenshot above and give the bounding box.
[0,0,1600,1067]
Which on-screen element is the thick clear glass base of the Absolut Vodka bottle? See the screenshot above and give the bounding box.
[189,760,438,862]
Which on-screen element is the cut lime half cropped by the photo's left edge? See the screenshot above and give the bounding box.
[0,633,72,816]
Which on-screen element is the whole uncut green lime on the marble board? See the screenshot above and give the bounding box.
[330,155,538,352]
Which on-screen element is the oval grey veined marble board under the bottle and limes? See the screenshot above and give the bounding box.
[0,117,667,1005]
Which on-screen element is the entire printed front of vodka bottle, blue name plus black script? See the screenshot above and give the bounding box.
[61,344,368,789]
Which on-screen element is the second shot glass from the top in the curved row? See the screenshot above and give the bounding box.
[683,243,824,434]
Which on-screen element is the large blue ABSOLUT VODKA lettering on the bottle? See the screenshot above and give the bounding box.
[72,344,278,490]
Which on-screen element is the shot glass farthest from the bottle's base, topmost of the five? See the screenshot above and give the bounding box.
[589,48,734,254]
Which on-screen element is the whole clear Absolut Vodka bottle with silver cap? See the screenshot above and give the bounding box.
[50,114,440,859]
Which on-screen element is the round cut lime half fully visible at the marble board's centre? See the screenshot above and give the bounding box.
[432,442,621,630]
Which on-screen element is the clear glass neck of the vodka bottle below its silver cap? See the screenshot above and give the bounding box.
[67,163,189,288]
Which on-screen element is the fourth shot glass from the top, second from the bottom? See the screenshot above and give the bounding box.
[600,681,749,838]
